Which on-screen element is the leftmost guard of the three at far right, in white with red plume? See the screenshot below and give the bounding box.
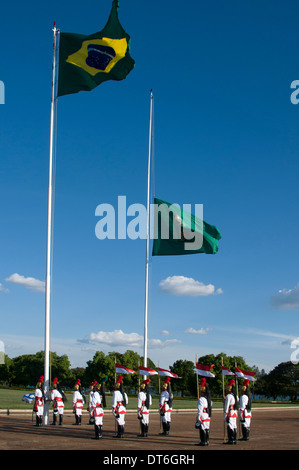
[195,378,212,446]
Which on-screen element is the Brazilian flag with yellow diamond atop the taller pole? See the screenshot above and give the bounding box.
[57,0,135,96]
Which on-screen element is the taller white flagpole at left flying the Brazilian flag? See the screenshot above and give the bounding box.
[44,23,59,425]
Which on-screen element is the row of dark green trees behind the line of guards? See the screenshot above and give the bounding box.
[0,350,299,401]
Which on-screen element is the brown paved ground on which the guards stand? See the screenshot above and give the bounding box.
[0,408,299,455]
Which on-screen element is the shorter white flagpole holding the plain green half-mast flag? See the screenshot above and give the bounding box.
[143,90,154,367]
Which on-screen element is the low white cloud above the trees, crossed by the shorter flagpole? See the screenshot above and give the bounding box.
[89,330,180,348]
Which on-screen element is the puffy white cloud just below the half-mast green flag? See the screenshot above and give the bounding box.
[159,276,223,297]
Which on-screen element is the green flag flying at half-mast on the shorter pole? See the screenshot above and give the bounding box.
[152,199,221,256]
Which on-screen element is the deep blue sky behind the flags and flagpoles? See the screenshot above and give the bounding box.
[0,0,299,371]
